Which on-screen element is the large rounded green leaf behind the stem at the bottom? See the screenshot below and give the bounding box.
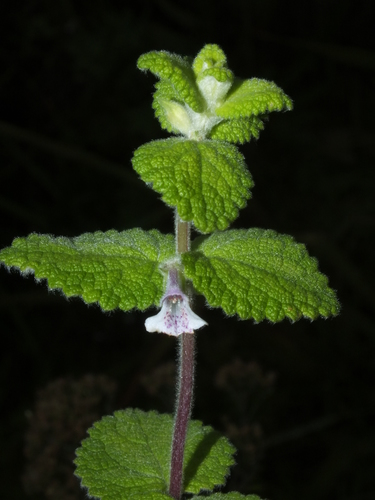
[75,409,235,500]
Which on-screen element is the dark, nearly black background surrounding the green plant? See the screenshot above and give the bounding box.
[0,0,375,500]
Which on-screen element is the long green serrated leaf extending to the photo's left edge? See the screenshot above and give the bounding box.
[0,229,175,311]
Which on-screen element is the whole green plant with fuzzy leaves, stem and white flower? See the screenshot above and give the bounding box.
[0,45,339,500]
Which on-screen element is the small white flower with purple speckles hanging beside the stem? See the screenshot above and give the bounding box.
[145,269,207,337]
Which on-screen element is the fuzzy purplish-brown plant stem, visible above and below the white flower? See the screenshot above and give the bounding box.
[169,211,195,500]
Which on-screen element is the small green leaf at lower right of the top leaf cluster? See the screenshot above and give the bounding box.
[209,116,264,144]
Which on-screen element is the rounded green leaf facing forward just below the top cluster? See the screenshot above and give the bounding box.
[132,138,253,233]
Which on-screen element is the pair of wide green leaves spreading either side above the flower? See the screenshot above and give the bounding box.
[0,228,339,322]
